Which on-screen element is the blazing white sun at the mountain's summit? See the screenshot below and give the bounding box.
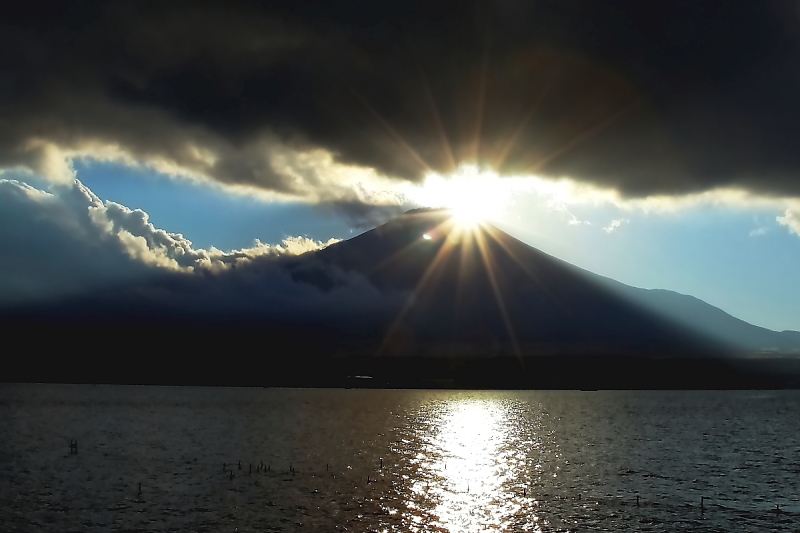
[414,165,512,228]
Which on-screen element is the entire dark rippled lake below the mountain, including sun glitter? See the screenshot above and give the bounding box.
[0,385,800,533]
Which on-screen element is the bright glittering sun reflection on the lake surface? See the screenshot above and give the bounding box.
[404,399,539,533]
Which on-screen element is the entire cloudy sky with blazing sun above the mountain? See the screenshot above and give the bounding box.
[0,0,800,330]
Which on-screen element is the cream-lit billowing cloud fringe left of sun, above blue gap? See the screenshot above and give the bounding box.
[7,120,406,210]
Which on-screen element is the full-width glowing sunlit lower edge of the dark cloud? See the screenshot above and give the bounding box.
[0,143,800,236]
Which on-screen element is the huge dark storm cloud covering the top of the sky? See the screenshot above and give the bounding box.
[0,0,800,196]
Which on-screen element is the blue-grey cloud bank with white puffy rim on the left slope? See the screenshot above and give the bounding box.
[0,179,336,304]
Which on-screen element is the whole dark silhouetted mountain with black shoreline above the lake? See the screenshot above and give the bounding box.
[0,210,800,389]
